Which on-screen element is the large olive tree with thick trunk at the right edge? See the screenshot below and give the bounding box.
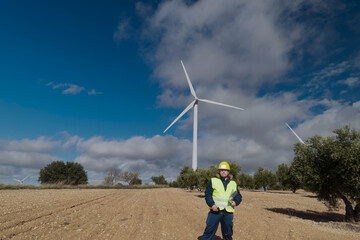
[292,126,360,222]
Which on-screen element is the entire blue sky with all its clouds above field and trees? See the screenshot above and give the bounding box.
[0,0,360,184]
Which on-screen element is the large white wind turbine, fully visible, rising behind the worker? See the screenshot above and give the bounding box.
[164,60,244,171]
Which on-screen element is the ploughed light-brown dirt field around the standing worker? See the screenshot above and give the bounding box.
[0,188,360,240]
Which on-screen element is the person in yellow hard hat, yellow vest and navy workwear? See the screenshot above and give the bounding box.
[201,162,242,240]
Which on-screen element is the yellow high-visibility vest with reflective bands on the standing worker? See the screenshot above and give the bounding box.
[210,178,237,213]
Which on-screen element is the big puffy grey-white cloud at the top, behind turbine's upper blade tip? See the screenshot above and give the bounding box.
[146,0,300,92]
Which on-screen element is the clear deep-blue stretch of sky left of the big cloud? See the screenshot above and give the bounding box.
[1,1,157,138]
